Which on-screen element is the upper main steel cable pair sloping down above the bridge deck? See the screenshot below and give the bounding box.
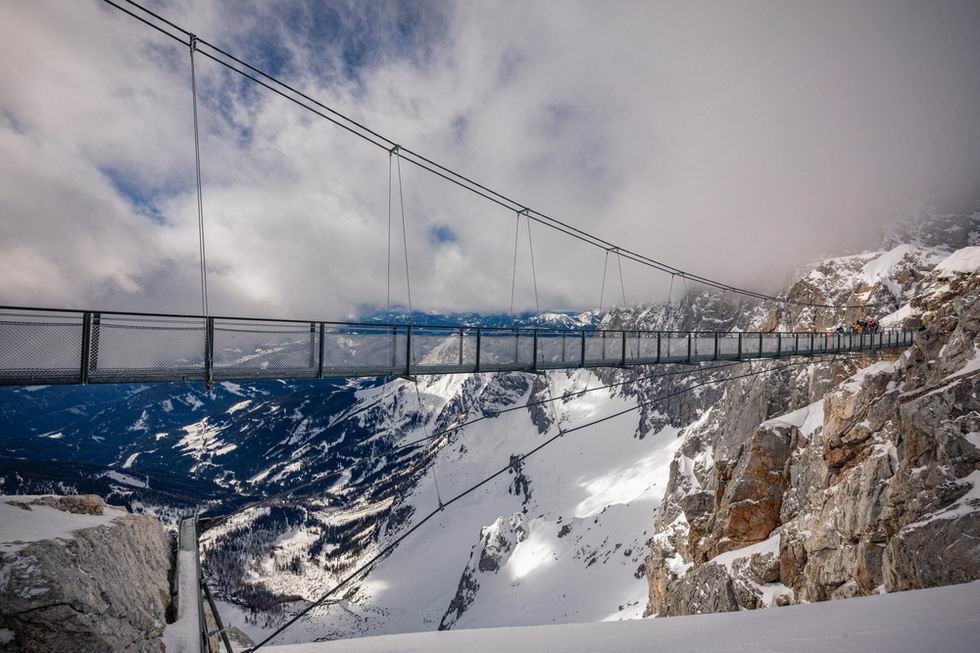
[102,0,872,308]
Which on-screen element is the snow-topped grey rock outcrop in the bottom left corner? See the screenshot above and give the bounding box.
[0,495,173,653]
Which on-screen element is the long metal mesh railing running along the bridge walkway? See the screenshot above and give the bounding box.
[0,307,912,385]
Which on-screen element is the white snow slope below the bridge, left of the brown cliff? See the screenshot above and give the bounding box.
[212,371,681,642]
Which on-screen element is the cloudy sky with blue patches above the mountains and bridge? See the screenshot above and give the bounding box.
[0,0,980,318]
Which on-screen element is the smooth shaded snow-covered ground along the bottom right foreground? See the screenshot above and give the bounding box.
[268,582,980,653]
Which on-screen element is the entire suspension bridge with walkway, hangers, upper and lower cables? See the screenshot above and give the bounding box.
[0,0,928,652]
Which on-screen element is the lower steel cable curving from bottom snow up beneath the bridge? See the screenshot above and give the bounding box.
[248,354,856,653]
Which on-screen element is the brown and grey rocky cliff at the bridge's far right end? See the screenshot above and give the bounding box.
[647,247,980,615]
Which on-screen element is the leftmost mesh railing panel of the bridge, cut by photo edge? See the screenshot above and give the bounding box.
[0,313,82,380]
